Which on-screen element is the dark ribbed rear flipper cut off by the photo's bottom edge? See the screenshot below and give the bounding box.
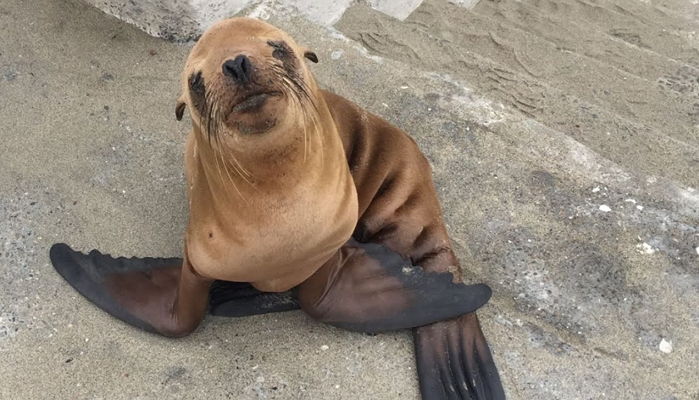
[413,313,505,400]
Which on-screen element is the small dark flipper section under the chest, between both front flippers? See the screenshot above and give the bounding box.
[209,281,300,317]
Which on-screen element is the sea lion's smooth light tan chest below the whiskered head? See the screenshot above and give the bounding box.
[186,134,358,292]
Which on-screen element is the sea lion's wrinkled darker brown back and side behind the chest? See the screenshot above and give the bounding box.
[321,91,452,272]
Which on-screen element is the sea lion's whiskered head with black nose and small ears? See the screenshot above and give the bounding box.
[176,18,317,150]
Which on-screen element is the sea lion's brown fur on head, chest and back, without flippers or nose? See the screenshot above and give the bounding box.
[181,19,456,291]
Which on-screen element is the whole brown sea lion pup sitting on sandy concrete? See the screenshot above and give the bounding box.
[50,18,504,400]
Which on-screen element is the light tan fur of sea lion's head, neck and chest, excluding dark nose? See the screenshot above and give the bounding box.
[181,19,357,291]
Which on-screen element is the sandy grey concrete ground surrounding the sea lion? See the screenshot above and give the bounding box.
[0,0,699,400]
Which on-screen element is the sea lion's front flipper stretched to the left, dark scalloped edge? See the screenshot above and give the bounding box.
[49,243,210,336]
